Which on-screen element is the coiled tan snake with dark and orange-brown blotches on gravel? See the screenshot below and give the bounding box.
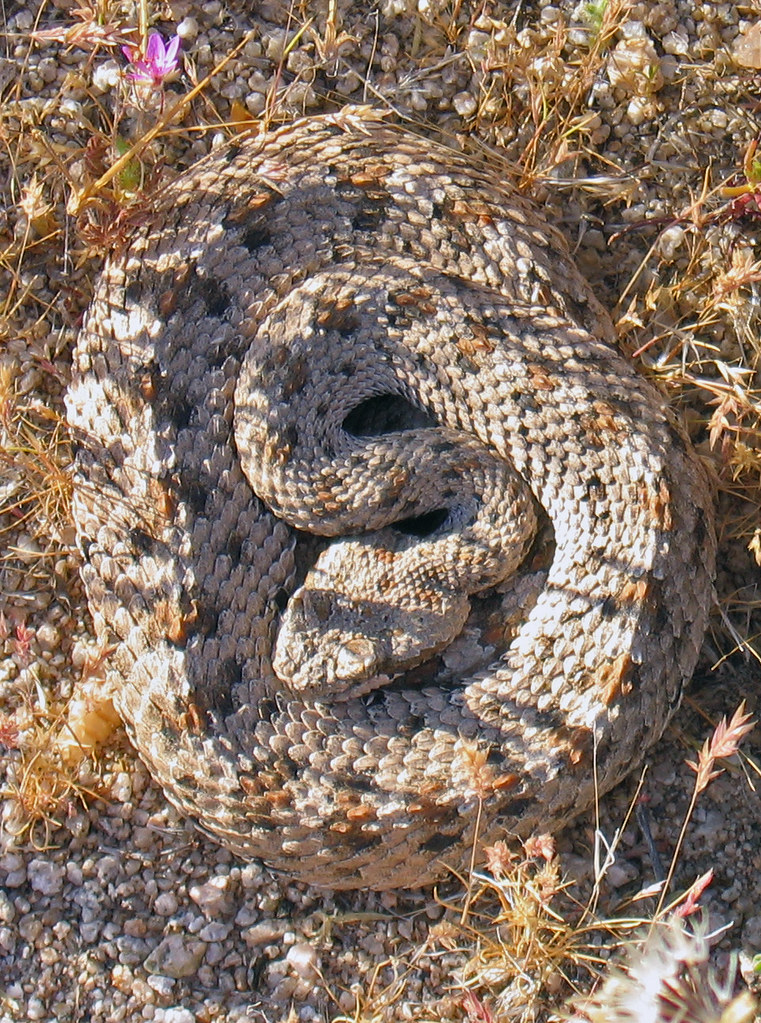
[66,108,715,889]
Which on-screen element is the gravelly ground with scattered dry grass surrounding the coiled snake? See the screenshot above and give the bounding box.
[0,0,761,1023]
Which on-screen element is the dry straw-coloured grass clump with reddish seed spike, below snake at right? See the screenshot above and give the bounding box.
[332,705,756,1023]
